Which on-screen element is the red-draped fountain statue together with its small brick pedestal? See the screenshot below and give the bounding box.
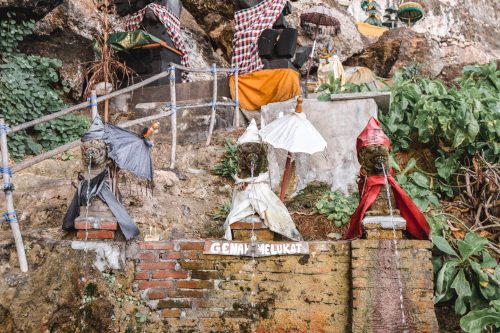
[344,117,430,240]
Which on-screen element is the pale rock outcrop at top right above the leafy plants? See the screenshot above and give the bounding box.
[347,0,500,77]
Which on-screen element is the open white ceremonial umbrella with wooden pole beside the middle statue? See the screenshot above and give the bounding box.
[259,97,326,201]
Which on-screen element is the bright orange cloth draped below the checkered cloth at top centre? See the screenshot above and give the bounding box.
[229,68,301,110]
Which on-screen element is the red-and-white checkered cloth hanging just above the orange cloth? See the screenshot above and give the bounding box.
[231,0,286,74]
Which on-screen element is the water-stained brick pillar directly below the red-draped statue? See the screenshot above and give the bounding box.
[351,240,439,333]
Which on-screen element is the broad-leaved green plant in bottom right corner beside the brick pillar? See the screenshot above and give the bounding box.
[432,232,500,333]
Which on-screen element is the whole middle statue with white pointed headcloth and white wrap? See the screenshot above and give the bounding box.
[224,120,302,241]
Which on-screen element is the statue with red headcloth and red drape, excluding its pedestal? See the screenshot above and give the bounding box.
[343,117,430,240]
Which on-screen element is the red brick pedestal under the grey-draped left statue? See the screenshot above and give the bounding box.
[75,199,118,239]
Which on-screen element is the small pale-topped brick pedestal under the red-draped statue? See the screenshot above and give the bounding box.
[362,215,406,239]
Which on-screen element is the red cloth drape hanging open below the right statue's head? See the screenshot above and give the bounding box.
[343,170,430,240]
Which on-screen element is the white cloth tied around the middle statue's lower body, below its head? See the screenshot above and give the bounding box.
[224,172,302,241]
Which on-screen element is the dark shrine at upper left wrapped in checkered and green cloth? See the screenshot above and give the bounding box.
[108,0,188,85]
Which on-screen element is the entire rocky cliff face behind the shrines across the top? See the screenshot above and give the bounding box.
[0,0,500,94]
